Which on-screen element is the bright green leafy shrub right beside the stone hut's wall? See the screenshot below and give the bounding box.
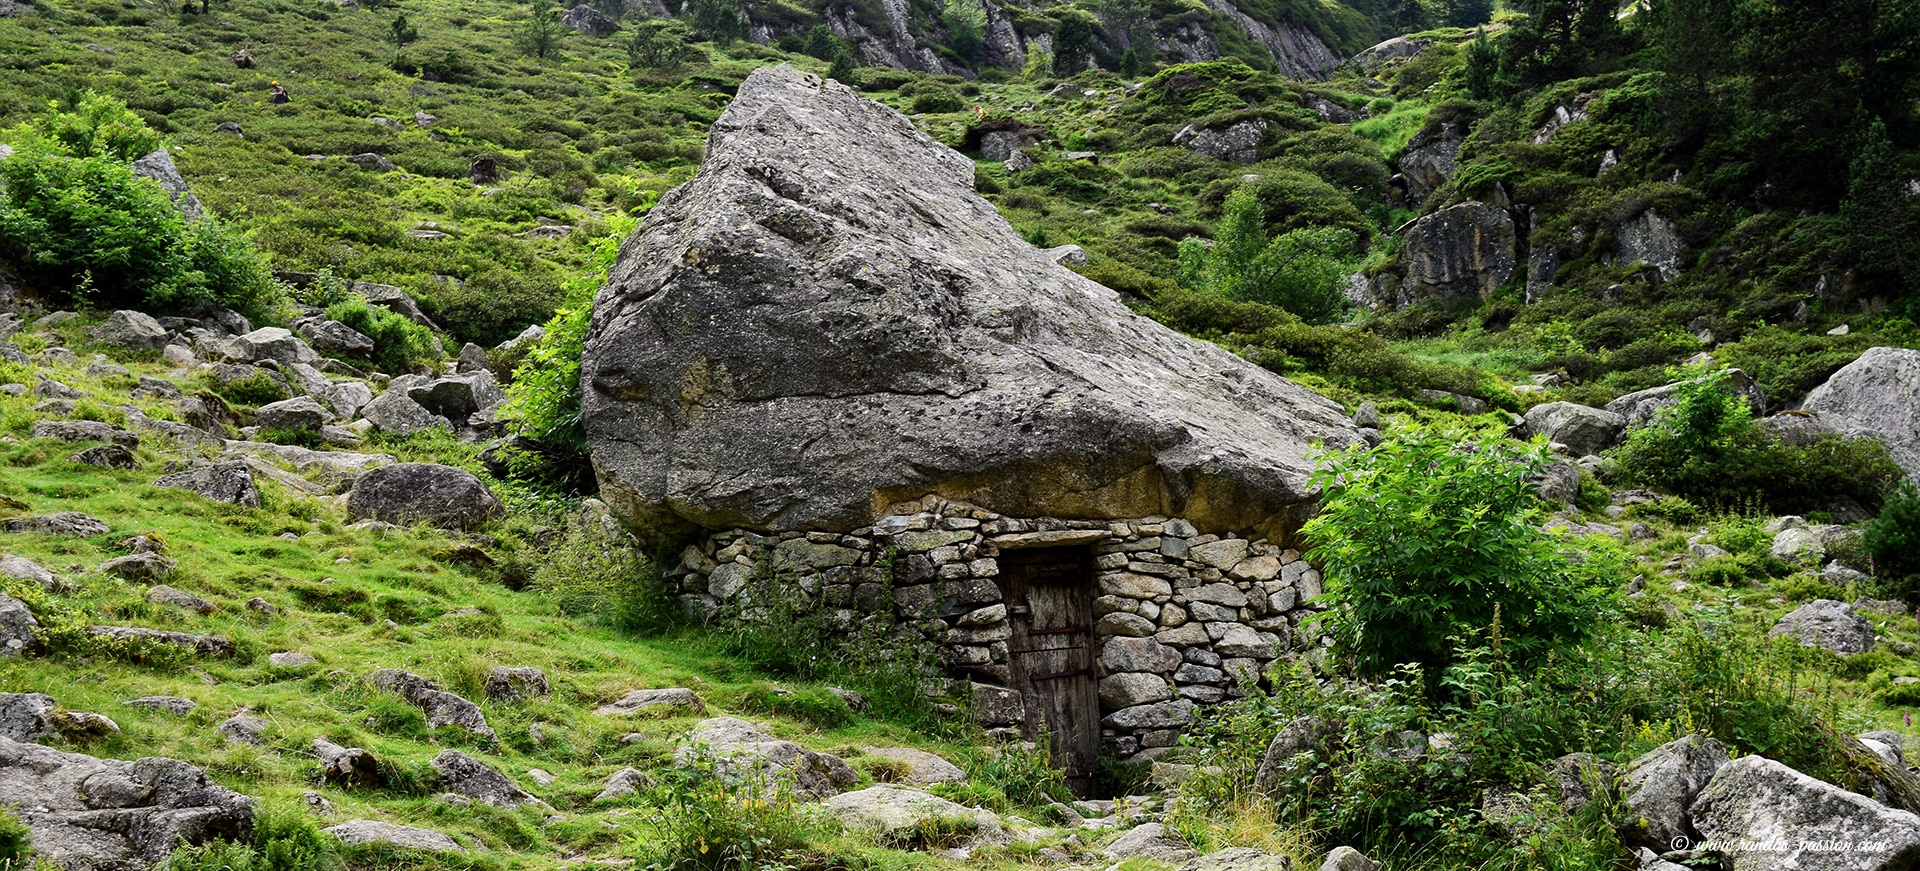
[1302,428,1607,689]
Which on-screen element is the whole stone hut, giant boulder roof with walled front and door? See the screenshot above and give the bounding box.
[582,67,1359,775]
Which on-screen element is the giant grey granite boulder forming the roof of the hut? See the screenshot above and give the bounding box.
[582,67,1359,539]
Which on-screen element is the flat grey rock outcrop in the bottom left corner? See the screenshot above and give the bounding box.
[0,737,253,871]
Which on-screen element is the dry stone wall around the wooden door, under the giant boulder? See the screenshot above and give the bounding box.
[670,497,1331,756]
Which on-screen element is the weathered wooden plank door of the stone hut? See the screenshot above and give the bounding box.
[1000,547,1100,790]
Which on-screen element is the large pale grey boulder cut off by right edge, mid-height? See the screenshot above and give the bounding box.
[1801,347,1920,483]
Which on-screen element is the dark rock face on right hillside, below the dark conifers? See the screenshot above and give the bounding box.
[1394,201,1519,309]
